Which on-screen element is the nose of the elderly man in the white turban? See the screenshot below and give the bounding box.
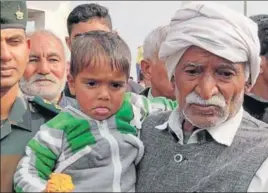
[195,74,219,100]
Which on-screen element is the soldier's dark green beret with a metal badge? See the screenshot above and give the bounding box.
[0,1,28,29]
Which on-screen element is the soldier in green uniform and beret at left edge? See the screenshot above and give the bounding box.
[0,1,60,192]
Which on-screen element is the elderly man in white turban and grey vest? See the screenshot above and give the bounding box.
[136,1,268,192]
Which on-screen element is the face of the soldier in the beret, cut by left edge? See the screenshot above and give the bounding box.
[0,29,30,90]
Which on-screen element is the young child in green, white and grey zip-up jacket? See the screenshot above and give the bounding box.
[14,31,177,192]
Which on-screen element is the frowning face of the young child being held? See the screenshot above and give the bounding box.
[68,59,128,120]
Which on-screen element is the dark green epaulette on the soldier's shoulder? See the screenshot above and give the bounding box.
[28,96,62,114]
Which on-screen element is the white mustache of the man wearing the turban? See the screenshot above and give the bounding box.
[186,92,226,108]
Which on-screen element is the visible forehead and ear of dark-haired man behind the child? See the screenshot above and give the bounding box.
[65,19,111,49]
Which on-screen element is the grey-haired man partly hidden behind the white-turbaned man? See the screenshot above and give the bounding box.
[141,26,175,100]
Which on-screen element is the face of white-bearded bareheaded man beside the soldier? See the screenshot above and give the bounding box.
[20,33,67,100]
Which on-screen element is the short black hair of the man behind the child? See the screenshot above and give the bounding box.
[67,3,112,35]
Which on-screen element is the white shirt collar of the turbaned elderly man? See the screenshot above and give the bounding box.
[156,107,244,146]
